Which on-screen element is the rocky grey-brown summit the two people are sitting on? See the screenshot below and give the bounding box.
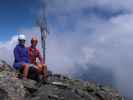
[0,60,124,100]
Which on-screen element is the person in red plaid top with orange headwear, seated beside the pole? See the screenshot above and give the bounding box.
[28,37,47,79]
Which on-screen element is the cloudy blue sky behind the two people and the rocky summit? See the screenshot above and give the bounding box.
[0,0,133,96]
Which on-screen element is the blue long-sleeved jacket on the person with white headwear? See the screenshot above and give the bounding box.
[14,44,30,67]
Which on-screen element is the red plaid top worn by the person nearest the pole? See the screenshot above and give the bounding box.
[28,47,44,64]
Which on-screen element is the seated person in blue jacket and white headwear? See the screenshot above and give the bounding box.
[14,34,29,79]
